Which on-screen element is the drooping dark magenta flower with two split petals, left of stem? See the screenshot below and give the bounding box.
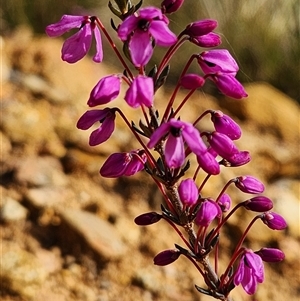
[77,108,116,146]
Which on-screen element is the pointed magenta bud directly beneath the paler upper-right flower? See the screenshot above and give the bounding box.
[209,72,248,99]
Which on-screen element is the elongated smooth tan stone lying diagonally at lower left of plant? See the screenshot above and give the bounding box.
[60,209,126,260]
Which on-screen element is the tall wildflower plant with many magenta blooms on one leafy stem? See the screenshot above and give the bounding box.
[46,0,287,300]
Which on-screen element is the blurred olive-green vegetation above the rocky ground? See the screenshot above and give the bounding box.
[0,0,300,102]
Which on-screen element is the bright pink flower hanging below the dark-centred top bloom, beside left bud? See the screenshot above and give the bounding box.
[125,75,154,108]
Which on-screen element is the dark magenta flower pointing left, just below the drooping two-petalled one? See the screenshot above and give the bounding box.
[100,150,147,178]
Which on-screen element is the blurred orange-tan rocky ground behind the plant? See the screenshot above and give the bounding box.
[0,29,300,301]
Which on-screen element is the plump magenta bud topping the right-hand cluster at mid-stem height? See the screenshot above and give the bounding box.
[211,111,242,140]
